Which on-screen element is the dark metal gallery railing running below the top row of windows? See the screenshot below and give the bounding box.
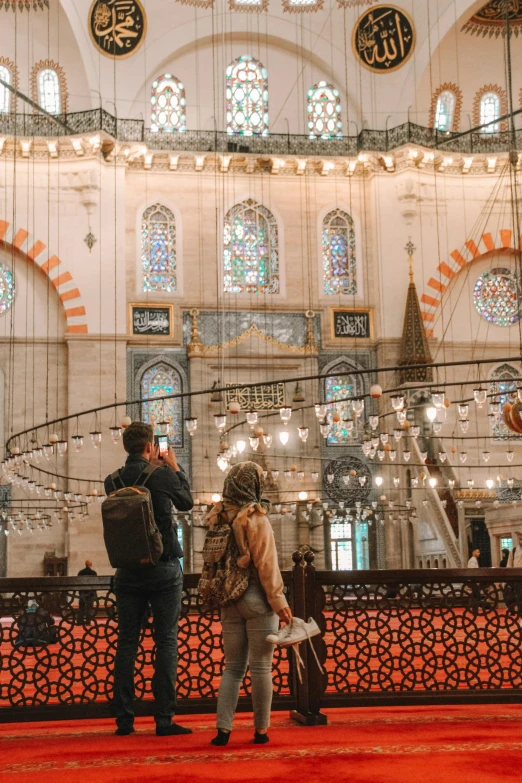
[0,109,522,157]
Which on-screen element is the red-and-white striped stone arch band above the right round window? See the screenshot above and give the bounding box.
[420,228,522,337]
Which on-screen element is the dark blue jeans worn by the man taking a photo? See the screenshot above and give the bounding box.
[113,559,183,728]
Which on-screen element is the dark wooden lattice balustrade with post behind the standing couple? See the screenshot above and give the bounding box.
[0,552,522,724]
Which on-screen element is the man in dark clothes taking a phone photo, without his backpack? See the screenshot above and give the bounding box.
[105,422,193,737]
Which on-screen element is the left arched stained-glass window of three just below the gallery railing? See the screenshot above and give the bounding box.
[141,204,176,291]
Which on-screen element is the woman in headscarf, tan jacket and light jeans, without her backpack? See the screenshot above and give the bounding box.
[207,462,292,746]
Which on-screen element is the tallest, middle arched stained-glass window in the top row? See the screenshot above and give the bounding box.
[226,54,268,136]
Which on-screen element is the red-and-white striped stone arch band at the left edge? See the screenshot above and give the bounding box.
[0,220,89,334]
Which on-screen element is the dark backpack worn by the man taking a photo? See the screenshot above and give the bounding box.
[102,465,163,568]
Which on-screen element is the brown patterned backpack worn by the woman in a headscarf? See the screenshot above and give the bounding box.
[198,514,250,606]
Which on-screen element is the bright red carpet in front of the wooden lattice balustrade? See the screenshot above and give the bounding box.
[0,705,522,783]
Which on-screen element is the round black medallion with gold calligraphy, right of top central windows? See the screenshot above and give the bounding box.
[352,5,415,73]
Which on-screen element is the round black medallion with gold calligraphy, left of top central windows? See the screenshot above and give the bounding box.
[88,0,147,59]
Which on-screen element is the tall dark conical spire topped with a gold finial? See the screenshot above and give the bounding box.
[397,241,433,385]
